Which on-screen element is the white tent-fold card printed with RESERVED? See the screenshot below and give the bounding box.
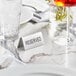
[18,32,44,50]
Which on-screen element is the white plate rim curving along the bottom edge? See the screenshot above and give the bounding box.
[0,64,76,76]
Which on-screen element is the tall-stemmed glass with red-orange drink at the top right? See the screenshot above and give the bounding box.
[54,0,76,66]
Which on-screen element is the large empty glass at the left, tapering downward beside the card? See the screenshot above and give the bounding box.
[0,0,21,58]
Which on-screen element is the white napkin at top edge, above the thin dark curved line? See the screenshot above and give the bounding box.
[22,0,49,11]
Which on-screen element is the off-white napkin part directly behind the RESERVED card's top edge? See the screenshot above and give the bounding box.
[19,22,48,37]
